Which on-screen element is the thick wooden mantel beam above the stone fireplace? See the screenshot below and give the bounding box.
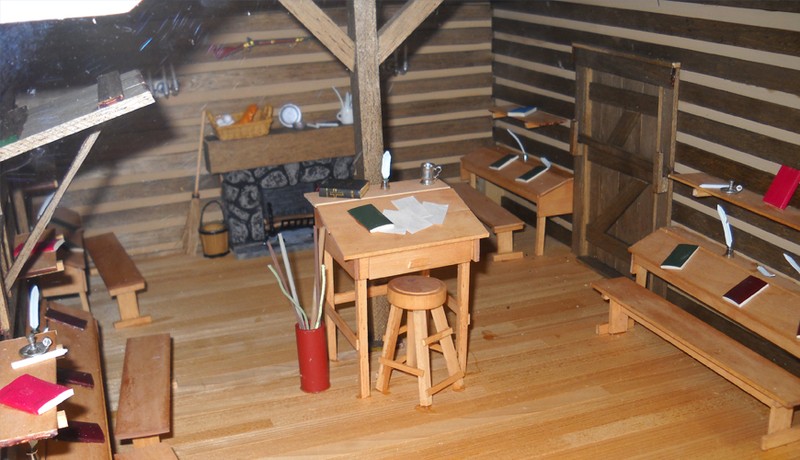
[205,126,355,174]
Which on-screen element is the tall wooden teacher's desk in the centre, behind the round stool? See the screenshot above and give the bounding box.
[306,180,489,398]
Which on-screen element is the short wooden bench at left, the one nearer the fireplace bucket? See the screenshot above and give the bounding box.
[84,233,152,329]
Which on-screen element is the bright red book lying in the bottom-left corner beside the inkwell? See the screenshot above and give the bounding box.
[0,374,75,415]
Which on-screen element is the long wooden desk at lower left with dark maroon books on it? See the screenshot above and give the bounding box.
[40,302,111,460]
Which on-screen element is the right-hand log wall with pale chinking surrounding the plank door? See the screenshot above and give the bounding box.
[492,0,800,279]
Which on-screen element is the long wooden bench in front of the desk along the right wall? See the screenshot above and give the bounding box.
[592,278,800,450]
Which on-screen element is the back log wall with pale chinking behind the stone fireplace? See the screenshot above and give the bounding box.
[42,2,492,254]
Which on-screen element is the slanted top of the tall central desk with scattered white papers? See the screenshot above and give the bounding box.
[306,180,489,260]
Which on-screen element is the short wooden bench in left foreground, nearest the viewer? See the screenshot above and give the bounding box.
[114,334,172,448]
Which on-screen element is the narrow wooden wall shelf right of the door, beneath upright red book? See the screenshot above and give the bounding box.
[669,173,800,230]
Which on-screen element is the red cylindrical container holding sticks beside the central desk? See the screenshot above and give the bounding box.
[294,323,331,393]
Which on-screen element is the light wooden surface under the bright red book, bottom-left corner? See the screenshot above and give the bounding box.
[0,332,58,447]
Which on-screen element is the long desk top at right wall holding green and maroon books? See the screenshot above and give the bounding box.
[630,227,800,357]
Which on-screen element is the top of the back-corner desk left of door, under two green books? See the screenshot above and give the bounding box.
[461,146,574,202]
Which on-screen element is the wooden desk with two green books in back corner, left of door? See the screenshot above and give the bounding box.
[461,146,574,256]
